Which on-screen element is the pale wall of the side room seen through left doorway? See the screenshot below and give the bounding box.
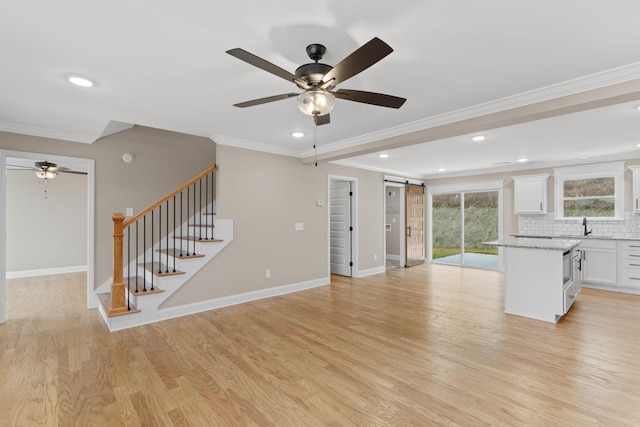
[6,170,87,272]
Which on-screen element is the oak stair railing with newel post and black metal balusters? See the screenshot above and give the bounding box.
[108,165,216,316]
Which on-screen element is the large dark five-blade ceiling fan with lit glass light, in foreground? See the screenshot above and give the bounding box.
[227,37,406,125]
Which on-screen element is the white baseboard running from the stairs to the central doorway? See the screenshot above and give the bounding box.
[158,277,331,320]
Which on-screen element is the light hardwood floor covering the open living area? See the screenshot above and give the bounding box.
[0,265,640,426]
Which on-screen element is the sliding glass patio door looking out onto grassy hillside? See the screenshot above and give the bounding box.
[431,190,500,269]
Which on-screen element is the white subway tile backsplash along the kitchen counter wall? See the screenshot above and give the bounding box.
[518,212,640,238]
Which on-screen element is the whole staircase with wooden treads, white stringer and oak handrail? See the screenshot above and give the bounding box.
[96,165,233,331]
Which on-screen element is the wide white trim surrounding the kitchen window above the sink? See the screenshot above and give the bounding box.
[553,162,624,221]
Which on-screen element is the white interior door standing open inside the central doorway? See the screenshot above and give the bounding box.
[329,179,353,277]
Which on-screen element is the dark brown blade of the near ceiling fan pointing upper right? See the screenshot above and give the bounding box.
[320,37,393,88]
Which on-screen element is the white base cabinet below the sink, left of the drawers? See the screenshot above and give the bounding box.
[580,239,617,286]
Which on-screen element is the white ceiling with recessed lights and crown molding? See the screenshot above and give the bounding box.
[0,0,640,178]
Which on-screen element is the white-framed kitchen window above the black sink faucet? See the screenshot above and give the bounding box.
[554,162,624,219]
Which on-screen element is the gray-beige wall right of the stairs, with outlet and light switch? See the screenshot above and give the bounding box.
[162,145,384,308]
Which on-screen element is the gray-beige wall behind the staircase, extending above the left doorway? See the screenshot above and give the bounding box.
[0,126,216,286]
